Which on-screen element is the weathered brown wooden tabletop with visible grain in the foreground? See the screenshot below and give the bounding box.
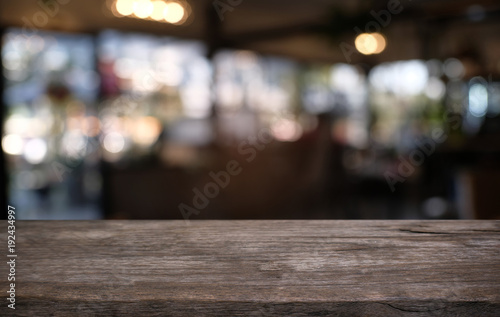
[4,220,500,316]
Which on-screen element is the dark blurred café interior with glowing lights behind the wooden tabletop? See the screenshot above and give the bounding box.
[0,0,500,220]
